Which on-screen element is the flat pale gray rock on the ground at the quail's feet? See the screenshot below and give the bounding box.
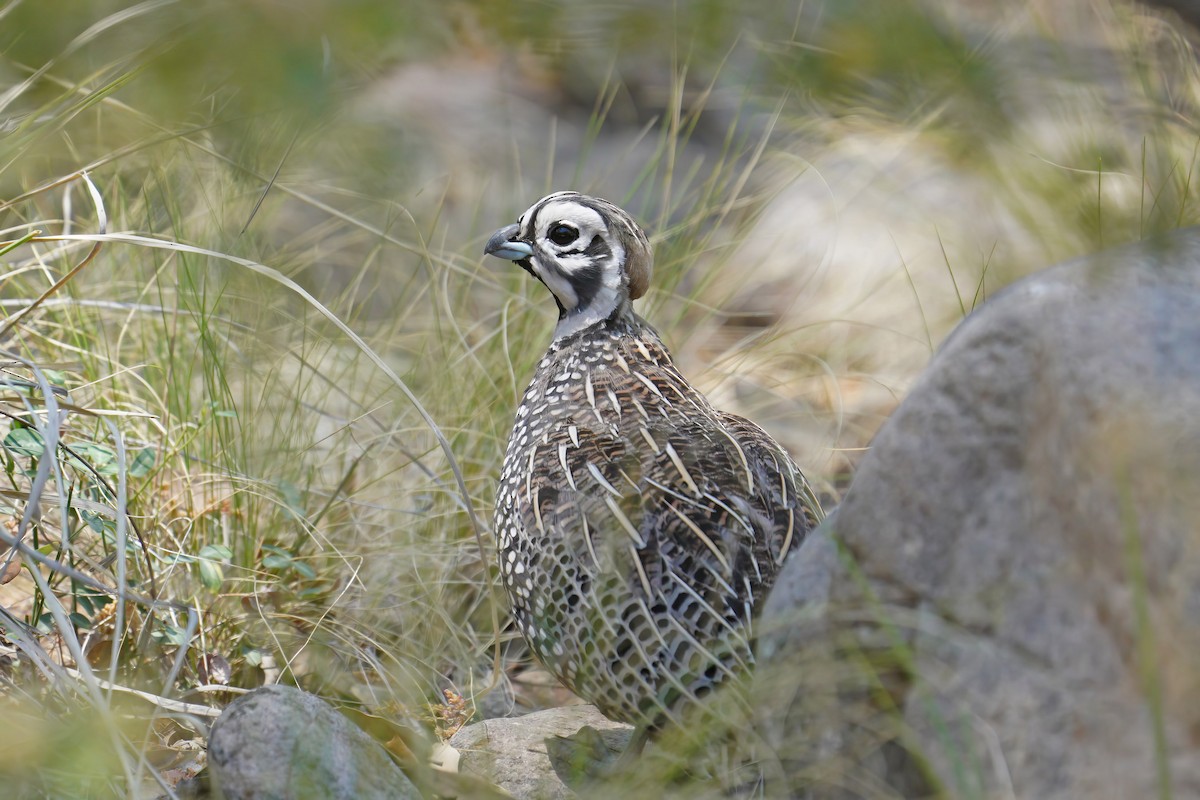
[450,705,634,800]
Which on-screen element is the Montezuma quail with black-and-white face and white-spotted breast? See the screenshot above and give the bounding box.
[485,192,820,729]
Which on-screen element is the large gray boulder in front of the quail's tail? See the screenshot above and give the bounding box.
[757,229,1200,800]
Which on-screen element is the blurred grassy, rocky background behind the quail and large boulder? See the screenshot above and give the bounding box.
[0,0,1200,796]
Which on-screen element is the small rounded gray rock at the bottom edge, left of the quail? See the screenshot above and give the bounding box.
[209,686,421,800]
